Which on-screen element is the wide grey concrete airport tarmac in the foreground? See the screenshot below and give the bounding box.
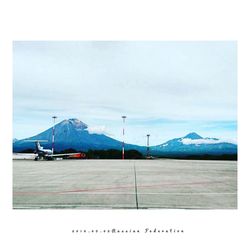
[13,159,237,209]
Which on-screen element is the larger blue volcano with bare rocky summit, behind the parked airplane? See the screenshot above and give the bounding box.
[13,119,143,152]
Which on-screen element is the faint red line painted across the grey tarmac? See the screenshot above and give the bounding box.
[13,181,223,196]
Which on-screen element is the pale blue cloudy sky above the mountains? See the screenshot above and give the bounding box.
[13,41,237,145]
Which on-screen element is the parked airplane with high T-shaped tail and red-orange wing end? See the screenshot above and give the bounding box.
[27,140,86,161]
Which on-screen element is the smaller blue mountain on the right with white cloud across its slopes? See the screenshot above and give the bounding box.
[150,132,237,155]
